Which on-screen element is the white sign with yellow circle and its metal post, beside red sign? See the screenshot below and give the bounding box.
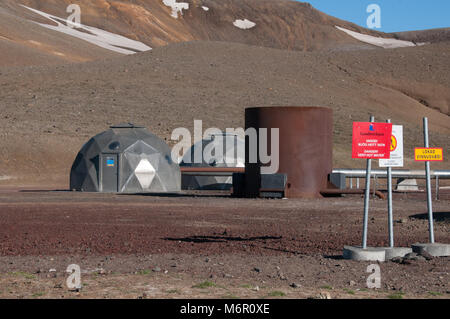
[379,120,403,248]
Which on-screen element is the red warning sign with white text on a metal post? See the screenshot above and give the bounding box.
[352,122,392,159]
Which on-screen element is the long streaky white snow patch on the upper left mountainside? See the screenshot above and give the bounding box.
[22,5,152,54]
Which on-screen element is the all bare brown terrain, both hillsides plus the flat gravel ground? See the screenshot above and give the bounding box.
[0,0,450,298]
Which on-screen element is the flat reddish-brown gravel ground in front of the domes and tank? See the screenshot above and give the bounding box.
[0,188,450,298]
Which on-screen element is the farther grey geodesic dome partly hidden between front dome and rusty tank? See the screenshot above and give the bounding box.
[180,134,245,190]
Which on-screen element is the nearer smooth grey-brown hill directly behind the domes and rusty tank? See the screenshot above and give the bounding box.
[0,42,450,184]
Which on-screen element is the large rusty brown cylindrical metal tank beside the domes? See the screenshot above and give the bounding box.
[245,106,333,198]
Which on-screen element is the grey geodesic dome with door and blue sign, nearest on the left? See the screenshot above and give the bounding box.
[70,124,181,193]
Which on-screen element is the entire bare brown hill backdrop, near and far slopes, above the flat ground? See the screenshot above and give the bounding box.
[0,0,450,186]
